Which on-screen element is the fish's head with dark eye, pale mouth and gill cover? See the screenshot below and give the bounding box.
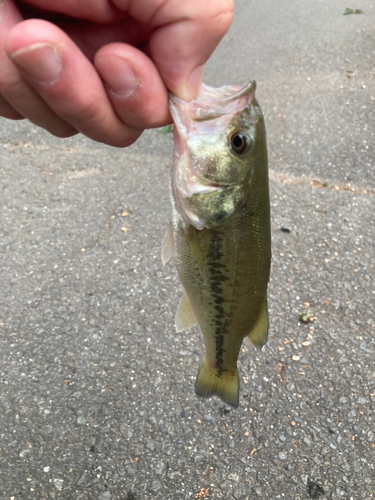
[170,82,267,229]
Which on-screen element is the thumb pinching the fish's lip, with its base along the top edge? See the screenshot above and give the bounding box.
[14,0,233,101]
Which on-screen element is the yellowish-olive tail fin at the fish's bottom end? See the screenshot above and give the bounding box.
[195,360,240,408]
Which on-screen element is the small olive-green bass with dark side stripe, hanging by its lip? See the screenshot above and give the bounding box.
[162,81,271,408]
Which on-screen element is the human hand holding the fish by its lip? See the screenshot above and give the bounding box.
[0,0,233,147]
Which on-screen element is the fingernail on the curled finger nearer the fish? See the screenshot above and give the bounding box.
[95,55,139,98]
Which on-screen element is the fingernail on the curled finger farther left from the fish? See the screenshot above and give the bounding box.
[11,43,63,85]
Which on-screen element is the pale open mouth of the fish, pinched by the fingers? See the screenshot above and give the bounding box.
[169,80,256,121]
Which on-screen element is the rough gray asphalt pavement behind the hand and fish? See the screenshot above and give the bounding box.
[0,0,375,500]
